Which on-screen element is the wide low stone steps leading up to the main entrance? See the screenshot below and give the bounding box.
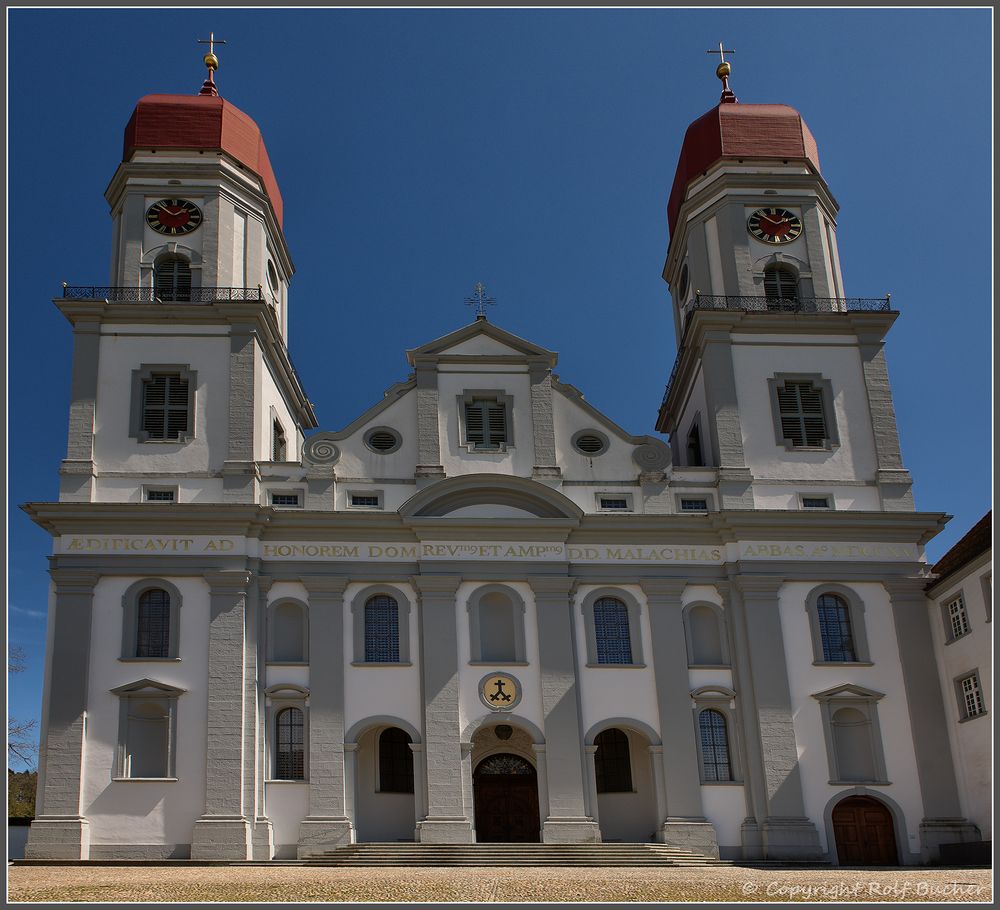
[305,842,728,866]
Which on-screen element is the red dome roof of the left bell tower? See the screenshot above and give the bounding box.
[122,95,283,224]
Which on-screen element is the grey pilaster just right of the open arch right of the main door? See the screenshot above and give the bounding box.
[640,578,719,857]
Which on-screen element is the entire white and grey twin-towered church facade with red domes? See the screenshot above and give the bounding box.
[25,60,979,864]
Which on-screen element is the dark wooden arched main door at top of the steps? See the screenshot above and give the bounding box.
[472,752,541,843]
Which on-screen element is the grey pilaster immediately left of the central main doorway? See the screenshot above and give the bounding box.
[413,575,475,843]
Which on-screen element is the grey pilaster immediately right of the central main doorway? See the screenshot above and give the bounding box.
[528,575,601,843]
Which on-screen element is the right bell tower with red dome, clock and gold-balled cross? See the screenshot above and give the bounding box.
[657,55,913,511]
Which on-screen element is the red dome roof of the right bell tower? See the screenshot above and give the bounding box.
[667,103,819,236]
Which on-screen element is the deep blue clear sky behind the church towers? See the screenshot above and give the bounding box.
[8,9,992,764]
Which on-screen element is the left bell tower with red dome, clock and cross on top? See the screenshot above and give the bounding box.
[55,44,315,502]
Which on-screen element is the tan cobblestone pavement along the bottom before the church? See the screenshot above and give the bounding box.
[7,866,993,903]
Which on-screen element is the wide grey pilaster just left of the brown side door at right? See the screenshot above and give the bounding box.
[730,575,822,859]
